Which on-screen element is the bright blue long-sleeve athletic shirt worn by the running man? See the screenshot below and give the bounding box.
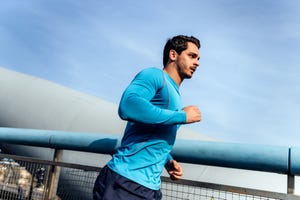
[108,68,186,190]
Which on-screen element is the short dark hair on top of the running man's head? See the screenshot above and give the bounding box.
[163,35,201,67]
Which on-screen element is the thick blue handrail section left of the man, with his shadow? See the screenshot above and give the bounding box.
[0,128,120,154]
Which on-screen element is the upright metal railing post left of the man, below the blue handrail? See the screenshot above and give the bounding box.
[47,149,63,200]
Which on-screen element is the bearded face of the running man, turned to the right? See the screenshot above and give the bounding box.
[175,42,200,80]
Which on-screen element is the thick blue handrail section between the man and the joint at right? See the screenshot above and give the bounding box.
[172,140,289,173]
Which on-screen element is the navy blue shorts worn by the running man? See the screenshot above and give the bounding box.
[93,166,162,200]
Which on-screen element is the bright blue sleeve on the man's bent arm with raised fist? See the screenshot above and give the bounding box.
[118,68,186,125]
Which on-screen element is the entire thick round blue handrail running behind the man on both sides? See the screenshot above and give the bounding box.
[0,128,300,175]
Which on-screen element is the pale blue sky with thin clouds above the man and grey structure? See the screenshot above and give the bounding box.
[0,0,300,146]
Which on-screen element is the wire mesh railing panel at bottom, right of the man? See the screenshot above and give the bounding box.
[161,177,300,200]
